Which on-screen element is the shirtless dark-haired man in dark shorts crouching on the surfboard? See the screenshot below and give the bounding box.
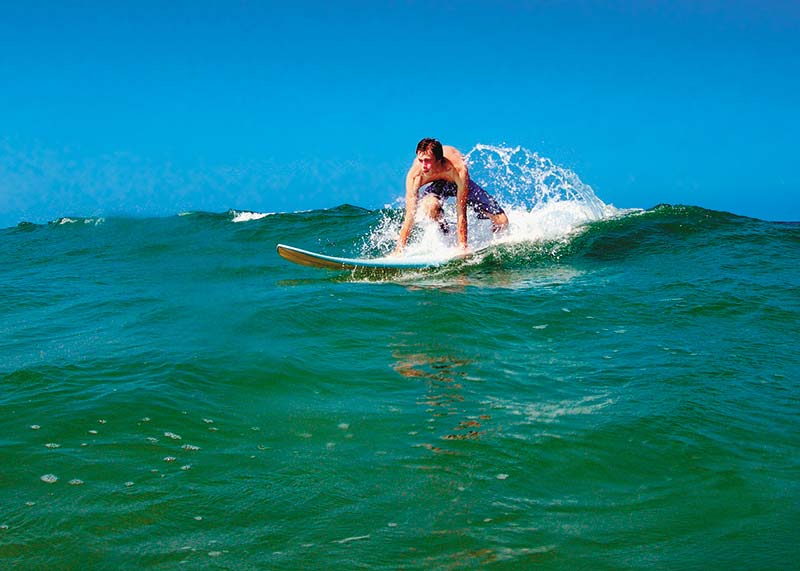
[395,139,508,253]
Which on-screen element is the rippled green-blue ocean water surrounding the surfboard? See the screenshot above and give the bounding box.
[0,150,800,570]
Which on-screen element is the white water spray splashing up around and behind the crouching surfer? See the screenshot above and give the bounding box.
[362,144,629,255]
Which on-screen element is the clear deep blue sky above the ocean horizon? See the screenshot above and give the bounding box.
[0,0,800,227]
